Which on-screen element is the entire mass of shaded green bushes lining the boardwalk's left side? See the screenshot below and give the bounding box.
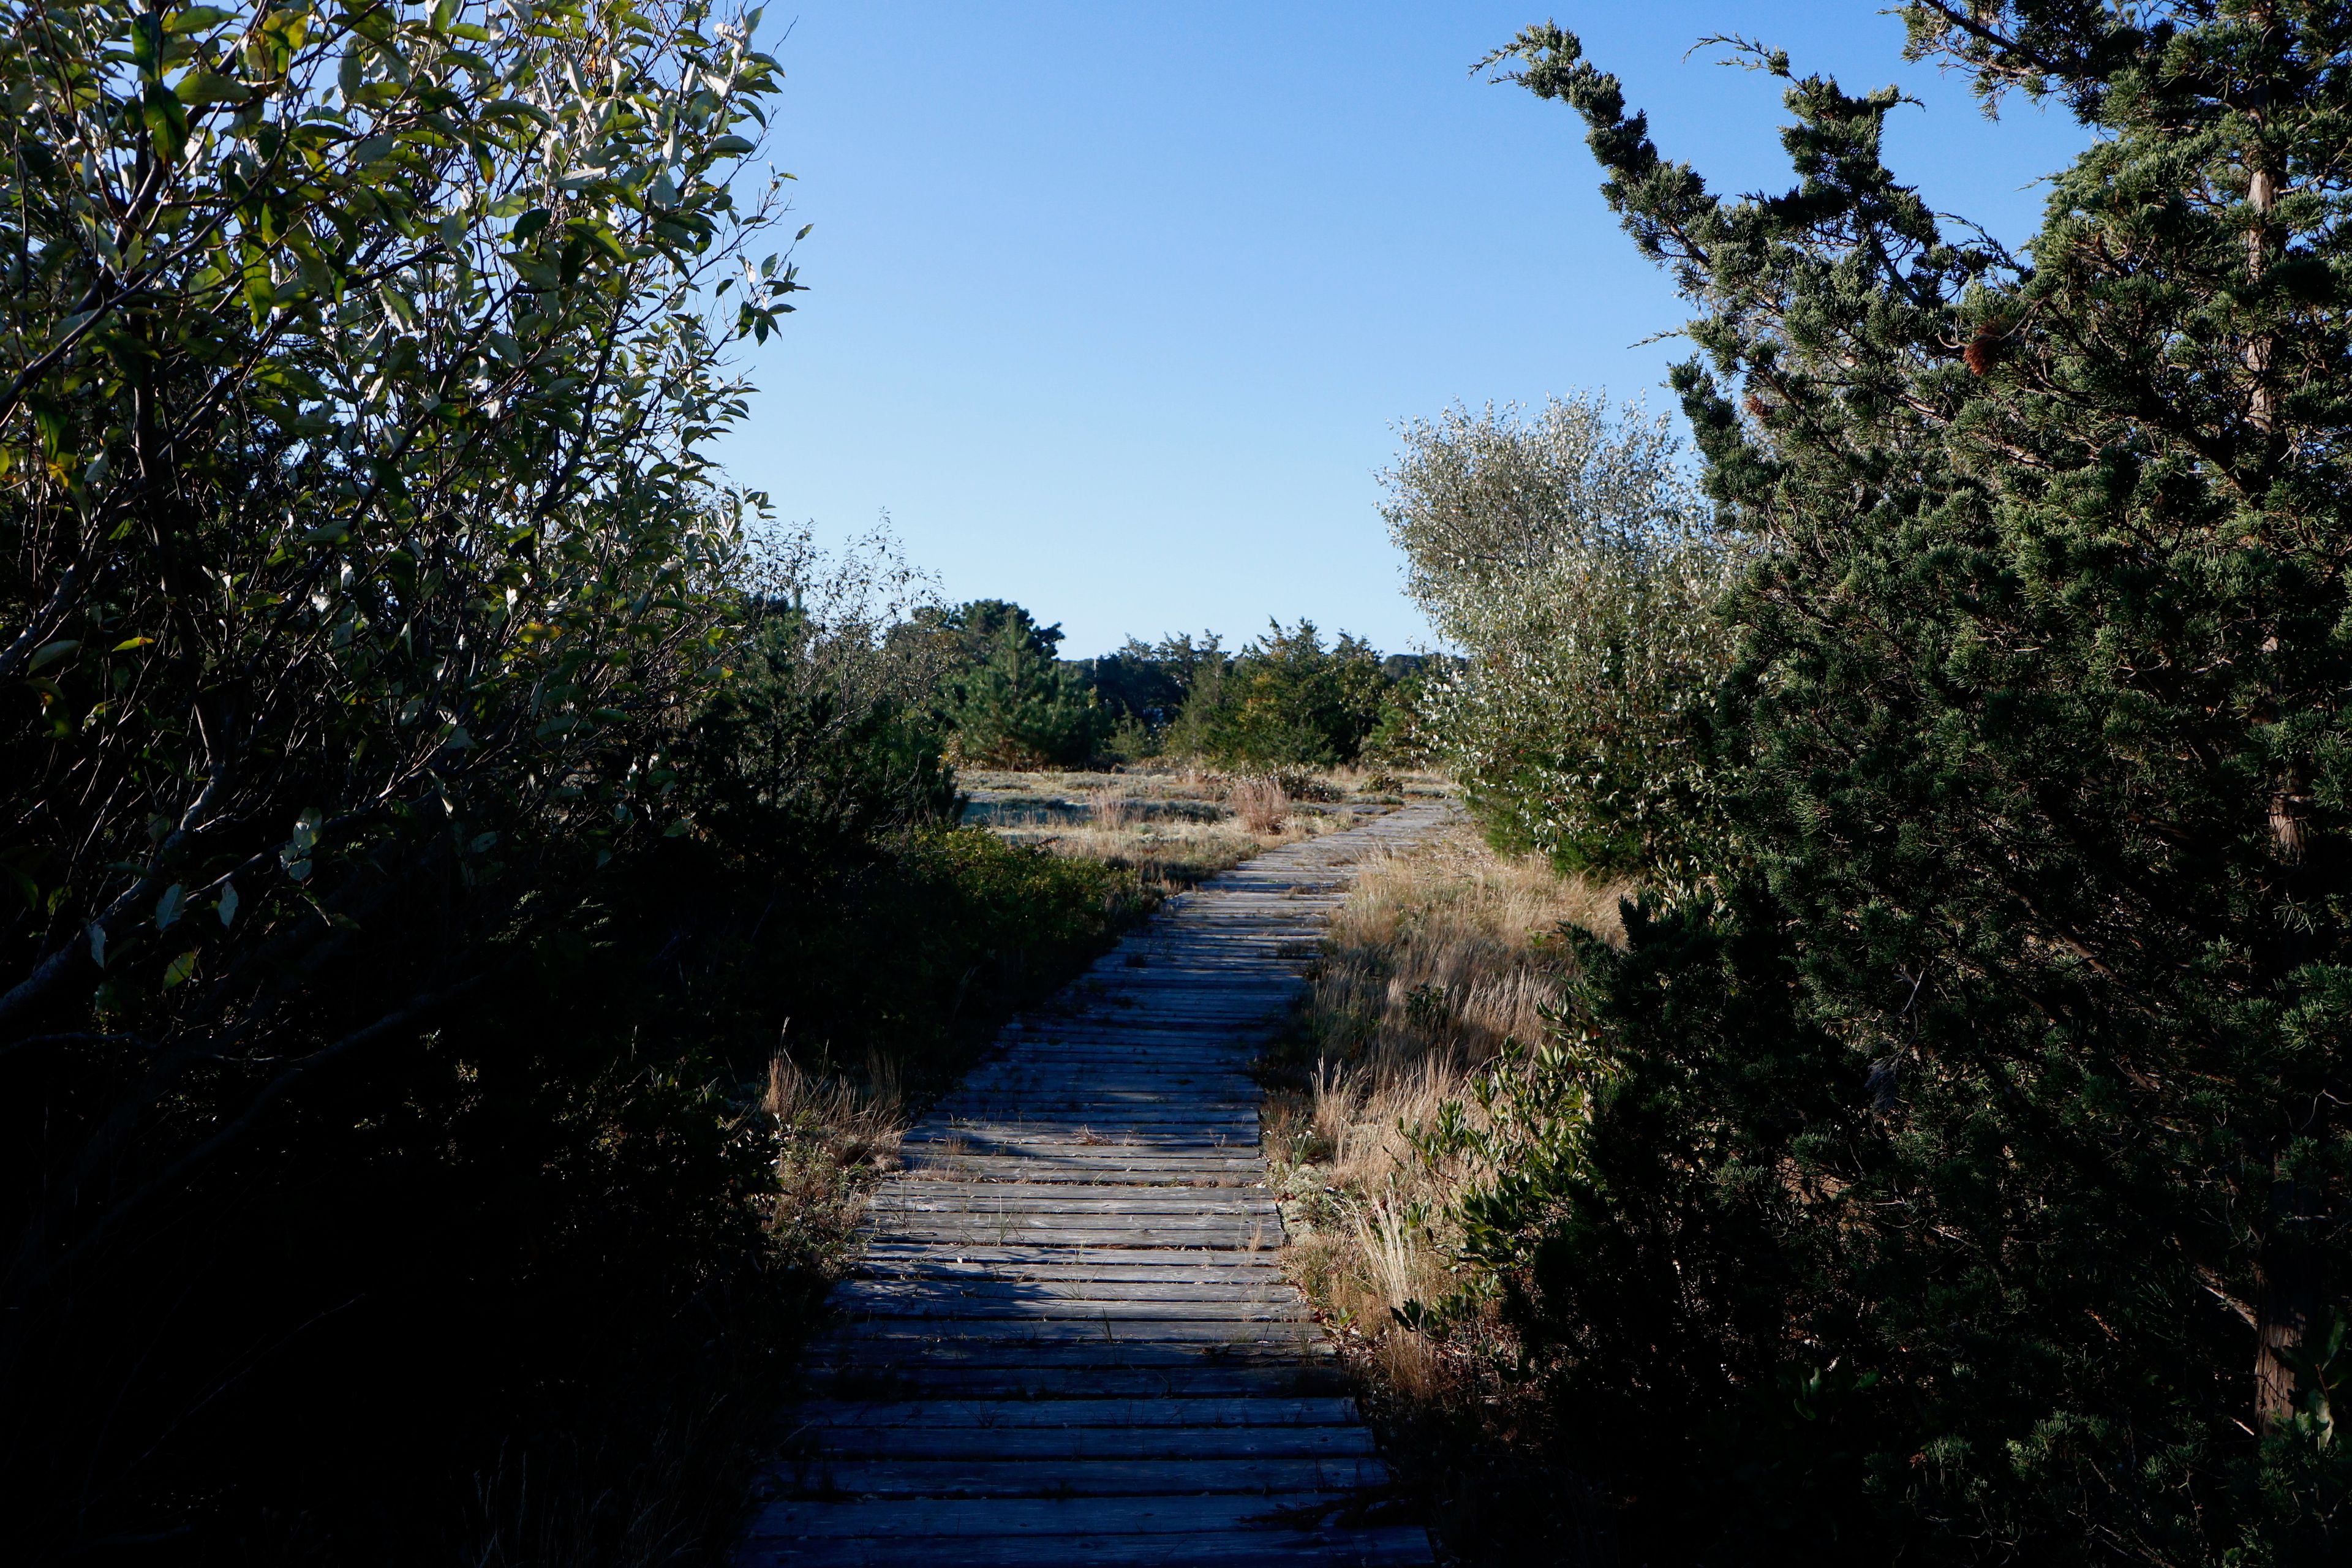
[0,0,1129,1566]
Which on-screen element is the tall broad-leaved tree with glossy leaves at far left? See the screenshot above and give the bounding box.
[0,0,797,1549]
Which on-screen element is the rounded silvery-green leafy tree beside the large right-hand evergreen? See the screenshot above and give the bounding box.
[1383,398,1736,881]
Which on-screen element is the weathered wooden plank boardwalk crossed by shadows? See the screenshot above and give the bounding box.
[739,804,1447,1568]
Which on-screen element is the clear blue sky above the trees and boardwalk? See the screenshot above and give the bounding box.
[725,0,2084,656]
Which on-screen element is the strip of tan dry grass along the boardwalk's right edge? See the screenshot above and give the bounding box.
[1265,825,1623,1563]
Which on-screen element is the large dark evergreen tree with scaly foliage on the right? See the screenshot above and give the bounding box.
[1472,0,2352,1563]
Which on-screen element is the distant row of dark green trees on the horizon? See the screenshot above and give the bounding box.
[891,600,1433,769]
